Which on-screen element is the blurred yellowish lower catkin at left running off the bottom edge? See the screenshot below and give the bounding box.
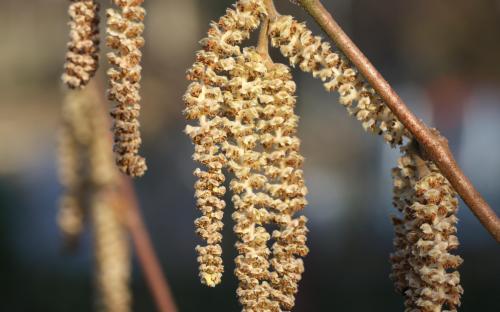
[92,192,132,312]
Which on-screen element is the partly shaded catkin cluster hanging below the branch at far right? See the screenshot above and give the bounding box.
[391,145,463,312]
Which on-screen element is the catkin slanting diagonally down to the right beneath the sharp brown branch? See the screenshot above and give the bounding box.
[269,16,409,146]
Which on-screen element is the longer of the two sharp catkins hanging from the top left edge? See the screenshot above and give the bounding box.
[106,0,147,177]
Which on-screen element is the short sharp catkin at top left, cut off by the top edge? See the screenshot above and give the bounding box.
[62,0,99,89]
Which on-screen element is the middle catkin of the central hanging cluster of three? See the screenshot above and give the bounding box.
[223,48,279,312]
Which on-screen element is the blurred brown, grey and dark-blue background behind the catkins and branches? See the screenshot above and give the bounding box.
[0,0,500,312]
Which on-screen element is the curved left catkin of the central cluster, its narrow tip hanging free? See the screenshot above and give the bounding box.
[184,0,265,287]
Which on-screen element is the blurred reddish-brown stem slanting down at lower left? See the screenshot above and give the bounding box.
[122,176,177,312]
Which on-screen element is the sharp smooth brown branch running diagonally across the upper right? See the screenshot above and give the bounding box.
[298,0,500,242]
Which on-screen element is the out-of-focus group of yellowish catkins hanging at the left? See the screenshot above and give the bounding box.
[58,83,131,312]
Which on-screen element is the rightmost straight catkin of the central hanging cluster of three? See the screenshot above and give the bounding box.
[257,63,309,311]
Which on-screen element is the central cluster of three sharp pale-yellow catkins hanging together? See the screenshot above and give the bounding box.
[184,0,308,312]
